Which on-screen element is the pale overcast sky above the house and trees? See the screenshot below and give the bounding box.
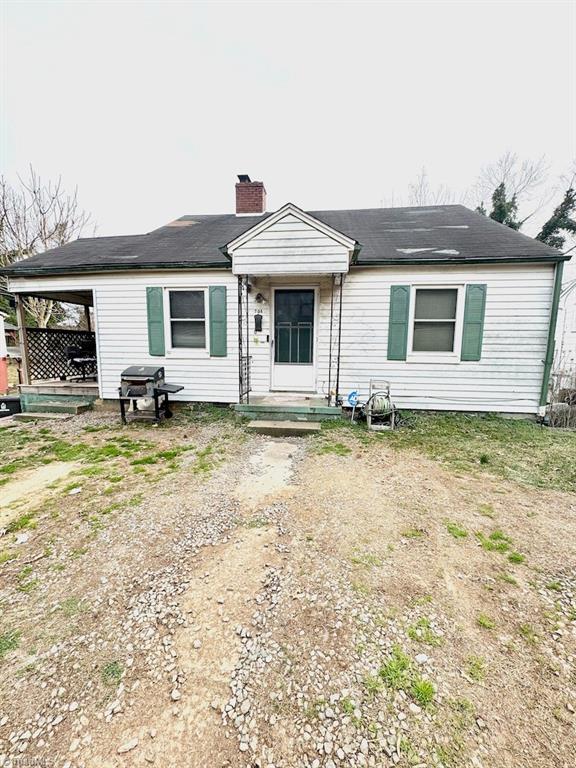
[0,0,576,235]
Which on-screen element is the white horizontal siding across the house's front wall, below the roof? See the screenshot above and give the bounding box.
[10,264,554,413]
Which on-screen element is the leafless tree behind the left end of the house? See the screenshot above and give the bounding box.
[0,166,91,328]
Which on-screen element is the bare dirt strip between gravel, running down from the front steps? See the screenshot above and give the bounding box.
[86,441,296,768]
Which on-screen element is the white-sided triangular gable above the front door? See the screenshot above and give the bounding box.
[233,214,349,275]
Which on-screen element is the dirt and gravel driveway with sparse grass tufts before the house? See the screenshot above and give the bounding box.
[0,415,576,768]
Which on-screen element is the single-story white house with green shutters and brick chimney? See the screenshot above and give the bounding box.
[3,176,567,414]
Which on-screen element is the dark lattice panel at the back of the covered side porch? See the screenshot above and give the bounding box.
[26,328,97,381]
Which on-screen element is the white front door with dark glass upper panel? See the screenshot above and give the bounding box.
[272,288,316,392]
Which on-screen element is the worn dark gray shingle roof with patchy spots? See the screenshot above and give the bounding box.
[2,205,567,276]
